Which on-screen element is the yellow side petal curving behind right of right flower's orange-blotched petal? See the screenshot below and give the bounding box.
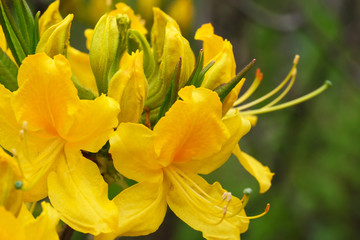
[175,109,250,174]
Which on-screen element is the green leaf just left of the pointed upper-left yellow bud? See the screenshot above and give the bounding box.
[14,0,37,54]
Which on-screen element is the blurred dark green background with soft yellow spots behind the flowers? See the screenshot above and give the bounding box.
[28,0,360,240]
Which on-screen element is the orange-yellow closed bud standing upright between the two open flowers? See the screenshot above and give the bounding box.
[108,51,148,123]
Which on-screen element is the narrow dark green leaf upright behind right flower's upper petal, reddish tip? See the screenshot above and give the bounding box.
[157,58,181,121]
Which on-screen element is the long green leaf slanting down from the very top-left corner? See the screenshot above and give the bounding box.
[0,1,29,66]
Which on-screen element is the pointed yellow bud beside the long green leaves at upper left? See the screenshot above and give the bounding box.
[36,14,74,57]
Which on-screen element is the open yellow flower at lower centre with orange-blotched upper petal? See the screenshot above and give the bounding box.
[107,86,258,239]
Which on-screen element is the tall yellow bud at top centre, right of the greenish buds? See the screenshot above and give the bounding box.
[145,8,195,109]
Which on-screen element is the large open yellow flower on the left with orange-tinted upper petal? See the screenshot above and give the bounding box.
[0,53,119,233]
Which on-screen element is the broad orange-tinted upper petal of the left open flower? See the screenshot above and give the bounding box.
[13,53,79,137]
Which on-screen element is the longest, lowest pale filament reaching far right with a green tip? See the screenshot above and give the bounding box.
[241,81,332,115]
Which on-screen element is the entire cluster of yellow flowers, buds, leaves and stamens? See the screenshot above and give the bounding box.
[0,0,329,239]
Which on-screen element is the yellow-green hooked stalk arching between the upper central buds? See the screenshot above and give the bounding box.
[126,29,155,78]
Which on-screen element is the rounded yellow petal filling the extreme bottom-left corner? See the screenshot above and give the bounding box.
[0,206,27,240]
